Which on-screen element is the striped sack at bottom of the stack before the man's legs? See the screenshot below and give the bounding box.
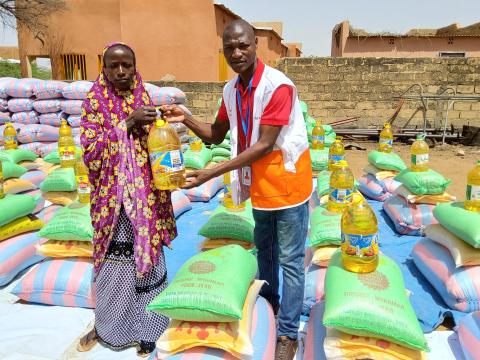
[150,297,277,360]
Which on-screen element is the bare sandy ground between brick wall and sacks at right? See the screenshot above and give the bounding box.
[346,141,480,201]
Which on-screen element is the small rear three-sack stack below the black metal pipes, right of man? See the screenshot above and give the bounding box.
[358,150,407,201]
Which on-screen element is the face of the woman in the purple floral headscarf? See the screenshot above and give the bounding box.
[103,46,135,91]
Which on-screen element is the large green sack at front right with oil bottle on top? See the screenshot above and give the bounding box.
[323,251,428,351]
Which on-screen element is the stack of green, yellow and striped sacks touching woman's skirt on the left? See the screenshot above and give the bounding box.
[12,203,95,308]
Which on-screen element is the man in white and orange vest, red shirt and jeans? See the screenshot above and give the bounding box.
[161,20,312,360]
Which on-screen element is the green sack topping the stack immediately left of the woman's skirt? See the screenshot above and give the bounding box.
[38,203,93,241]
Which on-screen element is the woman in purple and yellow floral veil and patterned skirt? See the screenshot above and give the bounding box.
[78,43,177,356]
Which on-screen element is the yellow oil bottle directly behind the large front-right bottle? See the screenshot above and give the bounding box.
[327,160,355,212]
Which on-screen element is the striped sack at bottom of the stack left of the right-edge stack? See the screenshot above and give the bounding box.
[383,195,438,236]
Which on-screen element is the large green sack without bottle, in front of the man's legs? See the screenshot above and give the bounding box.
[147,245,257,322]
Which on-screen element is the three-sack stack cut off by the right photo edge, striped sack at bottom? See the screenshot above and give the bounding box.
[412,202,480,312]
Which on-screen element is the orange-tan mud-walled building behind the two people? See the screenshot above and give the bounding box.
[18,0,300,81]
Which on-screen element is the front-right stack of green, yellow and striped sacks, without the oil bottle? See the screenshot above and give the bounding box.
[304,251,429,360]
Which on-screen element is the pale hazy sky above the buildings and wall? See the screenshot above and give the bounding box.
[0,0,480,56]
